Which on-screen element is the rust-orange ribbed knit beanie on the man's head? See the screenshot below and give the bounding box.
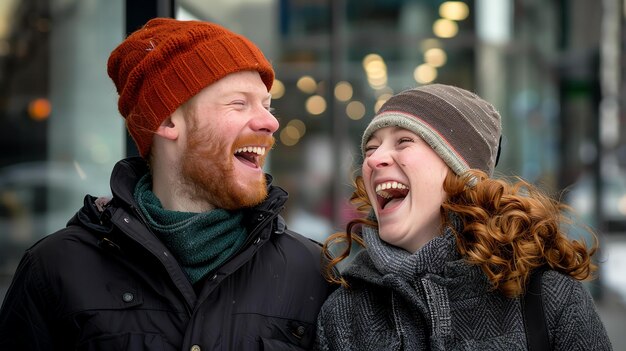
[107,18,274,157]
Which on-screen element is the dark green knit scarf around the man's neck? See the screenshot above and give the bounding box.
[134,174,247,284]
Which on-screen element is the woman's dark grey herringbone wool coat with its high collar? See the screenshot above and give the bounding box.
[316,228,612,351]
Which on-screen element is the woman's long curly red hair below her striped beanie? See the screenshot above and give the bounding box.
[323,170,598,297]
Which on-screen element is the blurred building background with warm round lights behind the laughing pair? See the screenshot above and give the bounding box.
[0,0,626,264]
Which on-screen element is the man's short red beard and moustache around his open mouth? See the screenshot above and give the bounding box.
[181,124,274,210]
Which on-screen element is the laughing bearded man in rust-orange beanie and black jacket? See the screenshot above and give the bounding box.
[0,18,331,351]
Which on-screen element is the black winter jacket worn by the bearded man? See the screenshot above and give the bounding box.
[0,158,332,351]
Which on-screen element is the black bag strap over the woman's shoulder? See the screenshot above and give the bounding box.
[522,268,550,351]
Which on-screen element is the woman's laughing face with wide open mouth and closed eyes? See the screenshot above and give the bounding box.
[362,127,450,252]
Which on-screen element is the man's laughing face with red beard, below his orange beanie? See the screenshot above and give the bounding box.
[181,71,278,210]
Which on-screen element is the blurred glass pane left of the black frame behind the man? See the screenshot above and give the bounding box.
[0,0,126,275]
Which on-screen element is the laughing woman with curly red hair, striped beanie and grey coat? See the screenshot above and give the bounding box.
[317,84,611,351]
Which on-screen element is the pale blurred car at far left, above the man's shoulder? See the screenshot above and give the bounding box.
[0,162,110,274]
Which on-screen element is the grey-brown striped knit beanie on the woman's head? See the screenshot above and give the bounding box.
[361,84,501,176]
